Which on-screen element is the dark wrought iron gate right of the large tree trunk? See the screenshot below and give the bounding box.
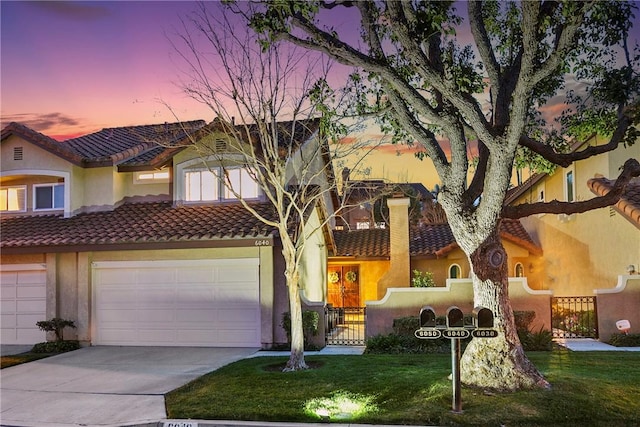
[551,296,598,338]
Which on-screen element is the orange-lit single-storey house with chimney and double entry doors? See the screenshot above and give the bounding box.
[327,198,542,307]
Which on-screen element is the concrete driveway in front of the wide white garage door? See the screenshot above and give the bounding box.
[0,347,258,427]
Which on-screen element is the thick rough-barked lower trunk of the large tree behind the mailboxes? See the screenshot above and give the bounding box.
[460,231,549,391]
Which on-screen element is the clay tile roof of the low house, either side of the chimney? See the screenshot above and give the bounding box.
[334,219,542,257]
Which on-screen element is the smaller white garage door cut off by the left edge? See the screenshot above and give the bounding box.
[0,264,47,344]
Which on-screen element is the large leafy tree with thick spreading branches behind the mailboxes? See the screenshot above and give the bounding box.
[246,0,640,390]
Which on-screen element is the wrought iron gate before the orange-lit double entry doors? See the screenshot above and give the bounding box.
[324,306,367,345]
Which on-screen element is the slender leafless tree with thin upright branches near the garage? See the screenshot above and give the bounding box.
[167,3,376,371]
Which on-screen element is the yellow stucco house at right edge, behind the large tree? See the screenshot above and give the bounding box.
[506,137,640,296]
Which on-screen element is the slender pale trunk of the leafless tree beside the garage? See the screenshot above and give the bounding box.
[283,245,308,372]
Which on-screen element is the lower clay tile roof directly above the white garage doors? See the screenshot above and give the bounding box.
[0,202,276,250]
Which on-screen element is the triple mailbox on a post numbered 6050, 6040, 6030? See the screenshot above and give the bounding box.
[414,306,498,414]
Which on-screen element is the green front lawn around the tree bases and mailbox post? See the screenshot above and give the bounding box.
[166,350,640,426]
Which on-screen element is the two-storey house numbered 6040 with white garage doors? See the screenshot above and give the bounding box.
[0,120,330,348]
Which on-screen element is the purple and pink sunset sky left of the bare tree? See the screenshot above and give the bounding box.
[0,0,638,139]
